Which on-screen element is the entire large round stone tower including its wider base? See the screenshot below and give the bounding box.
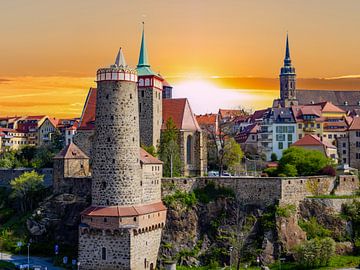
[79,49,166,270]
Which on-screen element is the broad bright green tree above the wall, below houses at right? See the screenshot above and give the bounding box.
[278,147,332,175]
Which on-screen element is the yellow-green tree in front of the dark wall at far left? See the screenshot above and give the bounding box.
[10,171,44,212]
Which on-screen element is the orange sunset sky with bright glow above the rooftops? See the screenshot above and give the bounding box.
[0,0,360,117]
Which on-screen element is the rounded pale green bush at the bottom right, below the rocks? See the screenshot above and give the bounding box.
[294,237,335,269]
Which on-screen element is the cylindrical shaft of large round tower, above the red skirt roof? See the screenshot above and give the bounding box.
[92,50,141,206]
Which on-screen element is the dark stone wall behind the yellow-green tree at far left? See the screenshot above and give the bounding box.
[0,168,53,187]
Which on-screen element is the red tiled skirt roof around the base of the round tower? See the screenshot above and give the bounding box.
[81,202,166,217]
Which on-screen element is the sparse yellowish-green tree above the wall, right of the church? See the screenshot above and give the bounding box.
[223,138,244,173]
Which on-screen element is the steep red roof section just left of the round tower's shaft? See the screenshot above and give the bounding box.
[79,88,97,129]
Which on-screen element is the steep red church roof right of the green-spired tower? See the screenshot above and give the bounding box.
[161,98,200,131]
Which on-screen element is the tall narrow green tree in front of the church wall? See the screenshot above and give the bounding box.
[159,117,181,177]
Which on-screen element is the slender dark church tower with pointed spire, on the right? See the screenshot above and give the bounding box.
[280,35,298,107]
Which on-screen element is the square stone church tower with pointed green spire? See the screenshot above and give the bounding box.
[137,23,163,147]
